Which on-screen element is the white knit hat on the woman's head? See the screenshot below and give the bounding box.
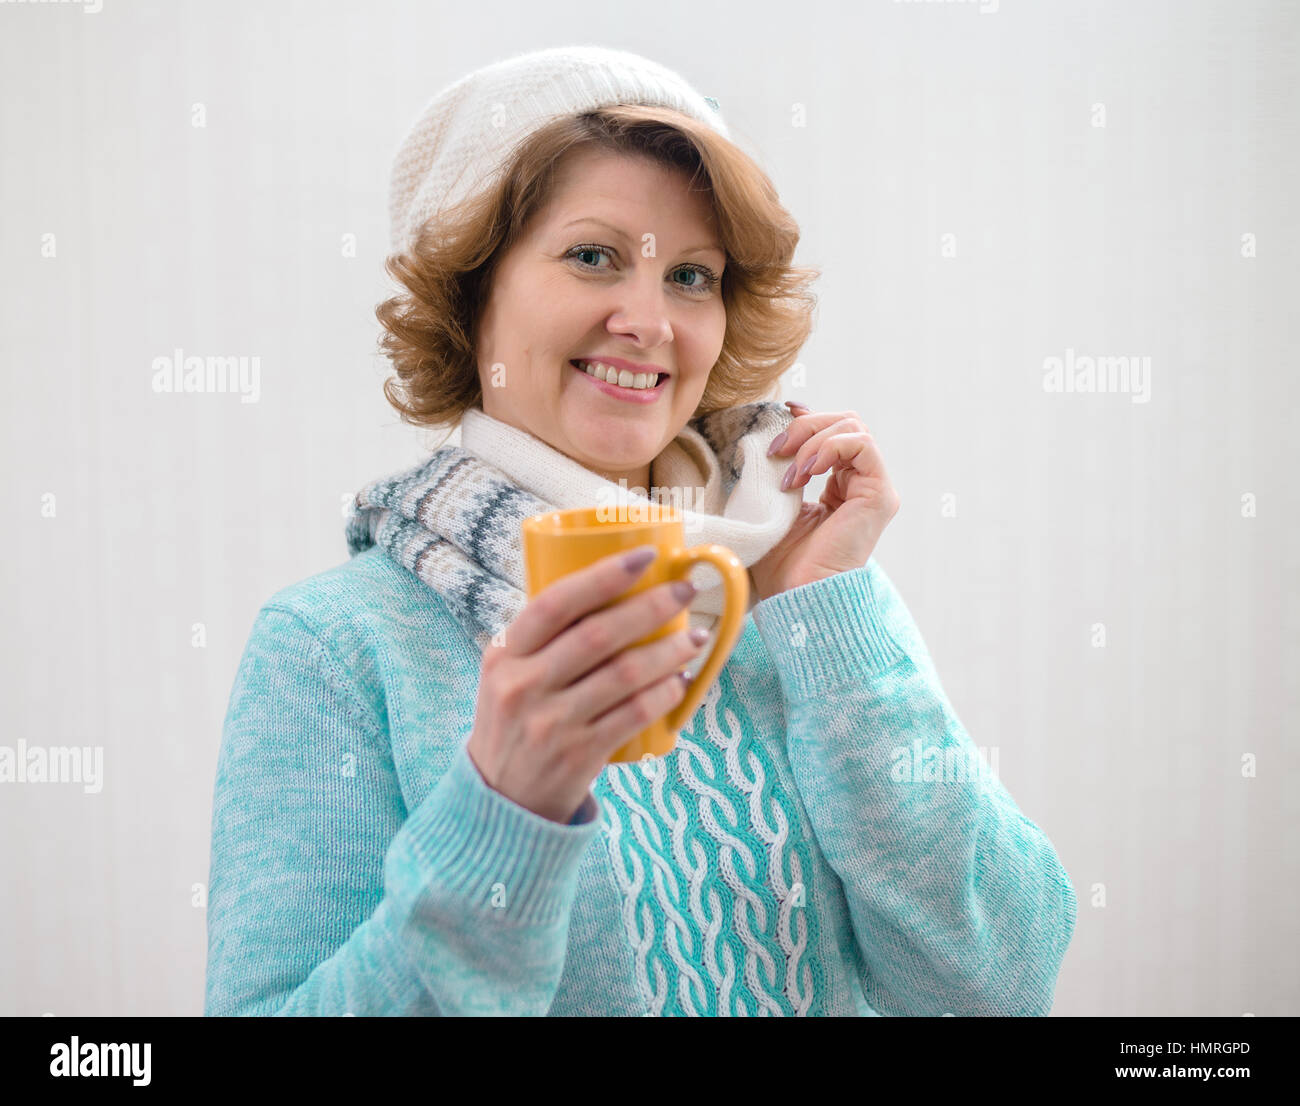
[389,45,729,252]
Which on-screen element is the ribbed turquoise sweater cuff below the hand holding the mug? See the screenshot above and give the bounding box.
[404,745,601,925]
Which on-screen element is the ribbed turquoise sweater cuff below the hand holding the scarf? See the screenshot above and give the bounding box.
[754,560,907,702]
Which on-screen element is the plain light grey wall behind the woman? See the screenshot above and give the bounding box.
[0,0,1300,1015]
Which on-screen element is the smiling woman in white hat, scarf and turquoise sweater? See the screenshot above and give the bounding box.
[205,48,1076,1015]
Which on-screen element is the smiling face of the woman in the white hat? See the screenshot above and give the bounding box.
[475,149,727,491]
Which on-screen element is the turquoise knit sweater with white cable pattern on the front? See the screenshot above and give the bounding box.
[204,547,1076,1015]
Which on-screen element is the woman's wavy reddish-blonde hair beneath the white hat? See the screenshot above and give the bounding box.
[374,104,820,426]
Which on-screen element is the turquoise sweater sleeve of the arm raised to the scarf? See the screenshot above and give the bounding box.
[754,560,1076,1015]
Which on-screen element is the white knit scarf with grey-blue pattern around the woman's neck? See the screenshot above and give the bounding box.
[346,402,803,658]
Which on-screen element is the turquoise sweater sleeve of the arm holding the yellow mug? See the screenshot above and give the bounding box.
[204,604,601,1016]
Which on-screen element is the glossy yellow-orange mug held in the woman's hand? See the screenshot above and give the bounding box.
[523,507,749,763]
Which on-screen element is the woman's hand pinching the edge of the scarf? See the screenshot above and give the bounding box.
[750,400,900,599]
